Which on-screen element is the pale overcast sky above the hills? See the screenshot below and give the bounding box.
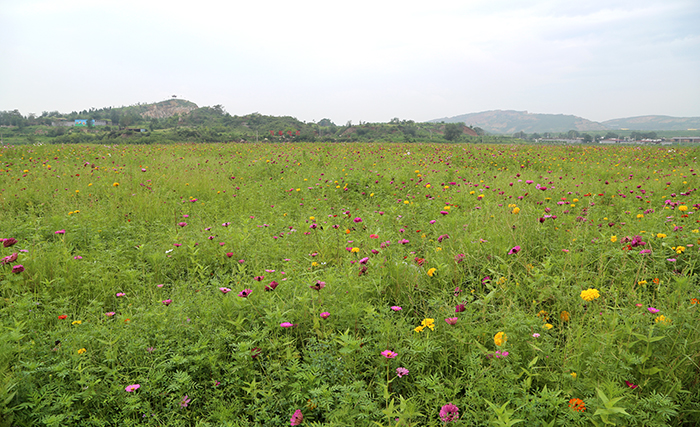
[0,0,700,124]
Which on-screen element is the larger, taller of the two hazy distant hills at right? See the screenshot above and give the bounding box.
[430,110,607,134]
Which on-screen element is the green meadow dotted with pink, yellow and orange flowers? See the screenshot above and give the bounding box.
[0,144,700,427]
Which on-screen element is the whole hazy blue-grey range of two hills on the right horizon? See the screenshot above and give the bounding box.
[429,110,700,134]
